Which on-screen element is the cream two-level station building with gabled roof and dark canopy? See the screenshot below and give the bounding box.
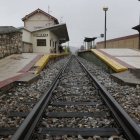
[20,9,69,53]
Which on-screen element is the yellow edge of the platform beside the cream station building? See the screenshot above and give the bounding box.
[34,53,68,74]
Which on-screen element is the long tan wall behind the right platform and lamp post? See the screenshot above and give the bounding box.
[96,34,139,49]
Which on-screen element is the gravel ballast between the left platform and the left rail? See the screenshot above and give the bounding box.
[0,58,68,140]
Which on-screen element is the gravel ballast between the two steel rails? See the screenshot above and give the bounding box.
[36,59,123,140]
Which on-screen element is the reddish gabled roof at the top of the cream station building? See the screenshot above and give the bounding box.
[22,8,59,24]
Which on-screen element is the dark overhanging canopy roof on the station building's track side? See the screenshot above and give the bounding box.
[32,23,69,43]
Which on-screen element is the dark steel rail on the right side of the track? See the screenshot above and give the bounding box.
[76,57,140,140]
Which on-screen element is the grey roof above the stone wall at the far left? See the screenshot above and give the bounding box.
[0,26,20,34]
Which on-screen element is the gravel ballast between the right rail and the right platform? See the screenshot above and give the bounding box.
[79,58,140,124]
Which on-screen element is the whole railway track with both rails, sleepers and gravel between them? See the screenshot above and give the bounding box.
[1,56,140,140]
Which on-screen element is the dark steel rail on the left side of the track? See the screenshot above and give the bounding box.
[11,56,72,140]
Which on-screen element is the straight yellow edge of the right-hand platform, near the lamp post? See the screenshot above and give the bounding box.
[91,49,128,72]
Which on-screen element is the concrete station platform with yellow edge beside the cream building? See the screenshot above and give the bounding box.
[0,53,68,91]
